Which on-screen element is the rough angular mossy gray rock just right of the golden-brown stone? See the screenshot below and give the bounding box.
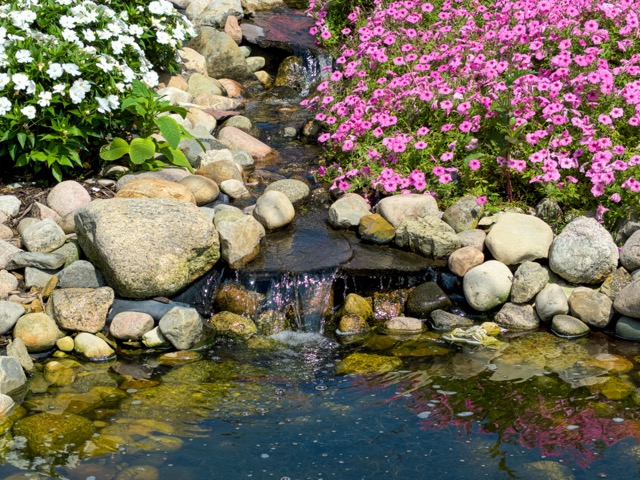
[395,216,460,260]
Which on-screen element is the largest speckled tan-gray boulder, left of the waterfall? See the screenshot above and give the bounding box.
[75,198,220,298]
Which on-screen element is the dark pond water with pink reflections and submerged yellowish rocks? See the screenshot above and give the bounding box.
[0,332,640,480]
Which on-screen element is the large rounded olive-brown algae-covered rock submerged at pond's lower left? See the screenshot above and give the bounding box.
[13,412,95,457]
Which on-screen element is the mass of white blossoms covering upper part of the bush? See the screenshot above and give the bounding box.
[0,0,194,120]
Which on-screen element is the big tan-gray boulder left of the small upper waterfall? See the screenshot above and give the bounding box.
[190,27,256,83]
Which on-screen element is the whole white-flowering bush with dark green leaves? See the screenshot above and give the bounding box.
[0,0,194,181]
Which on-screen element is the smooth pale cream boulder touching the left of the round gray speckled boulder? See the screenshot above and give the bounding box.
[485,213,553,265]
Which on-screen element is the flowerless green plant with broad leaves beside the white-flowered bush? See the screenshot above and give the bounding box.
[100,80,204,171]
